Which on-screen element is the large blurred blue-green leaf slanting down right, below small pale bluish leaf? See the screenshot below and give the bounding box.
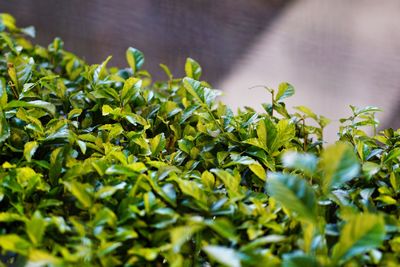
[266,173,317,223]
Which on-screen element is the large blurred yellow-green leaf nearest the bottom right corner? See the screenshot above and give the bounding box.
[332,213,385,263]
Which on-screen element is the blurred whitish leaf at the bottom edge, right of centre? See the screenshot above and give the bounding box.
[203,245,242,267]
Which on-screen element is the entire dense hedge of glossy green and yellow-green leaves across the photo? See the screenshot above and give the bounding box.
[0,14,400,267]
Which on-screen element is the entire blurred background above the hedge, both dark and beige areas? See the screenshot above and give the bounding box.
[0,0,400,139]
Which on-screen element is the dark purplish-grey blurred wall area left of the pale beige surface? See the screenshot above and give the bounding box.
[0,0,290,82]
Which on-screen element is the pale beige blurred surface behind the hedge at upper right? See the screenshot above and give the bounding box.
[218,0,400,140]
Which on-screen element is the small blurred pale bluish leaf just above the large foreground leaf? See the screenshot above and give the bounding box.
[282,151,317,175]
